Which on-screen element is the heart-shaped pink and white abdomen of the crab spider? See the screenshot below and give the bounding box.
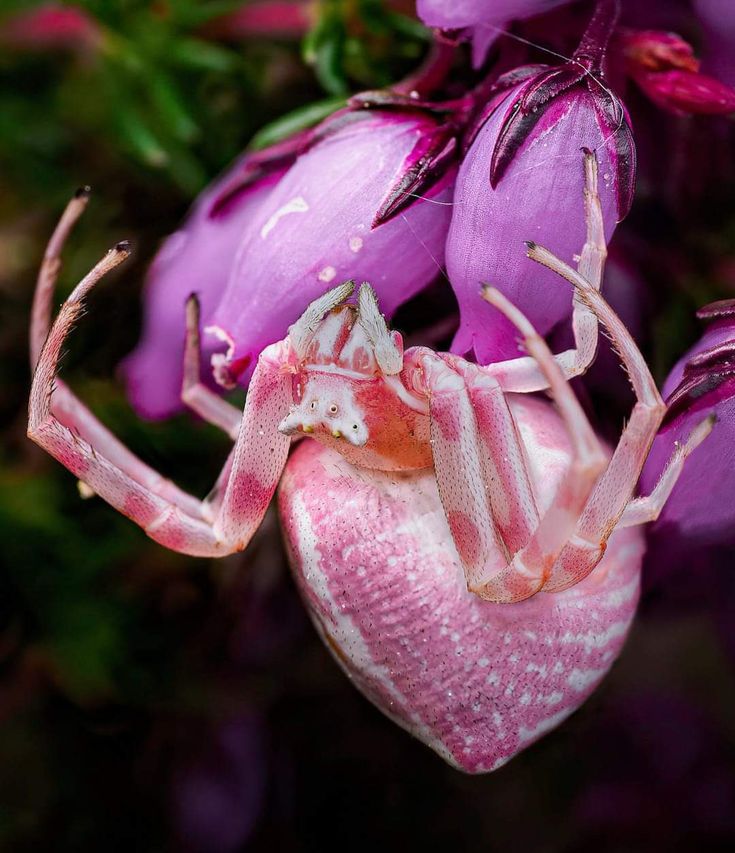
[279,402,644,773]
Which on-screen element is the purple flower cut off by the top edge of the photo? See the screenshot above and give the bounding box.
[416,0,569,66]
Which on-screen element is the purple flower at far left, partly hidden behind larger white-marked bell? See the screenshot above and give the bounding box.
[121,157,283,420]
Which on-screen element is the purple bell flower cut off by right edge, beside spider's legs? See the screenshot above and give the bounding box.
[641,299,735,563]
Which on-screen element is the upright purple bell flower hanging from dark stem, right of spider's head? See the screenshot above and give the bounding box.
[446,2,635,363]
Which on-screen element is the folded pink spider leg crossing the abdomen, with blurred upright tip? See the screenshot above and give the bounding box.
[420,282,606,602]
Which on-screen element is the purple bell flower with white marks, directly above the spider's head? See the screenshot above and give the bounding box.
[208,110,456,384]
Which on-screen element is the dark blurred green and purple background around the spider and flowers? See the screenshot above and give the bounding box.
[0,0,735,853]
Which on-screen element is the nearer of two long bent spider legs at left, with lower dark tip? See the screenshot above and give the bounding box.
[28,204,291,556]
